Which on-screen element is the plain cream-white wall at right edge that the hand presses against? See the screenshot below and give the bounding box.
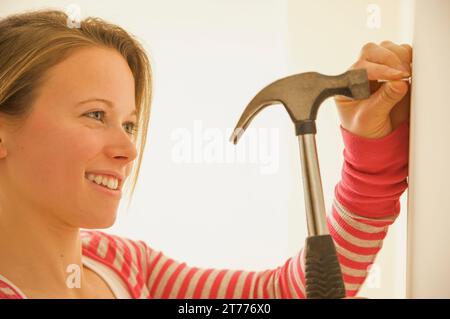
[407,0,450,298]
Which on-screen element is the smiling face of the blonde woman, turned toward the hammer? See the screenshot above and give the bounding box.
[0,48,137,228]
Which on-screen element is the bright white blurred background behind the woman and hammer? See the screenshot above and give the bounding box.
[0,0,428,298]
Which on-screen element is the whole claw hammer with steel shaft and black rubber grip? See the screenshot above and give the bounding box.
[230,69,370,299]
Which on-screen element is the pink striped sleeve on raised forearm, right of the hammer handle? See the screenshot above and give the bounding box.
[328,121,409,296]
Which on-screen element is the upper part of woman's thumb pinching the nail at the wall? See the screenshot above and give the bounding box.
[373,81,408,113]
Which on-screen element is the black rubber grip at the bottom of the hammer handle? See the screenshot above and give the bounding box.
[305,235,345,299]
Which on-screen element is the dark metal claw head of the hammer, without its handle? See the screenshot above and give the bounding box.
[230,69,370,144]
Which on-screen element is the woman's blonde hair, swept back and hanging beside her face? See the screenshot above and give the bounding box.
[0,10,152,208]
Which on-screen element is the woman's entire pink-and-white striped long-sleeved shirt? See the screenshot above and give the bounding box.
[0,122,409,299]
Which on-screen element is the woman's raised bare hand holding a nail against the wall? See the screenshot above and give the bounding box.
[334,41,412,138]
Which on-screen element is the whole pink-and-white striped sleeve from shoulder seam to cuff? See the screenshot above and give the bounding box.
[145,122,409,299]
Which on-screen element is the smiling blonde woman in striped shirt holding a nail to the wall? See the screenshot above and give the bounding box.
[0,11,411,298]
